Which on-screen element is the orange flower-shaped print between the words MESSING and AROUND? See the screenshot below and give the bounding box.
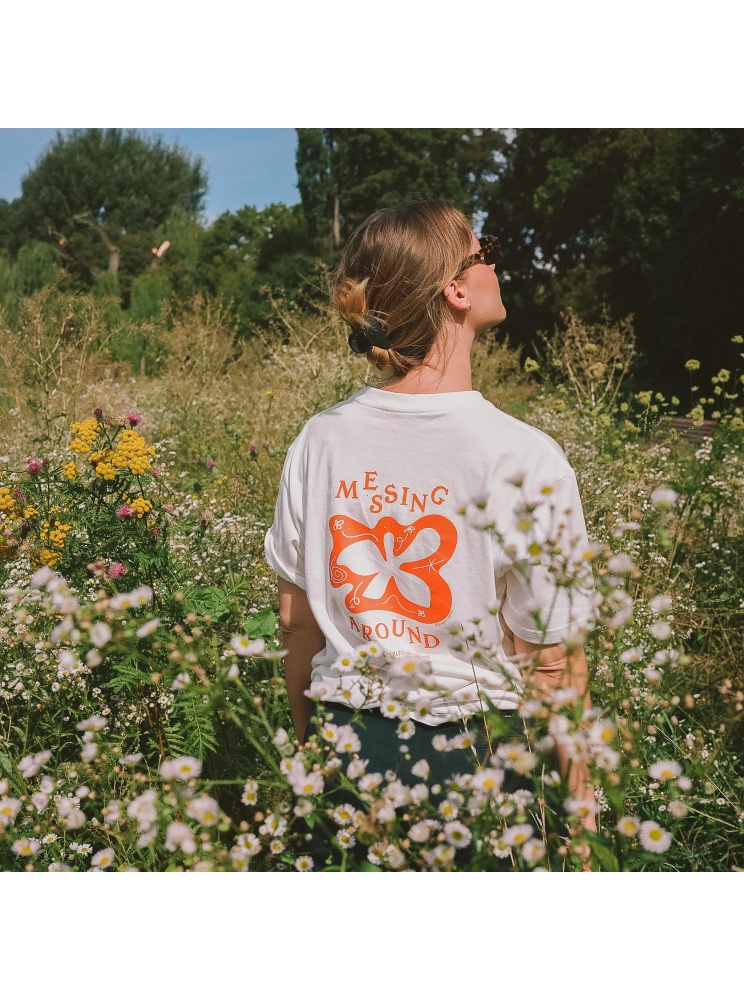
[328,514,457,624]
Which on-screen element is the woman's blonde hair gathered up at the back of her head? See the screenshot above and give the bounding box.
[334,201,473,380]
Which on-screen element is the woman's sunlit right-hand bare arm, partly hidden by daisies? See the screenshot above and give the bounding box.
[499,614,597,830]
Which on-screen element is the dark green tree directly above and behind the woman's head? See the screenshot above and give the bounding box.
[297,128,506,245]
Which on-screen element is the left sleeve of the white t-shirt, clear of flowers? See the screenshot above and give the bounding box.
[264,439,307,590]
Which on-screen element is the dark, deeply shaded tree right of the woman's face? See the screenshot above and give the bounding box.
[483,129,744,391]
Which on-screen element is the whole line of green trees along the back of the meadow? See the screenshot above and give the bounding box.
[0,129,744,389]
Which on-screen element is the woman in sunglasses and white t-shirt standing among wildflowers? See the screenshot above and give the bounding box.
[266,201,592,825]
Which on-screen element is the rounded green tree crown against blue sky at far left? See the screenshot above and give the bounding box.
[11,129,207,280]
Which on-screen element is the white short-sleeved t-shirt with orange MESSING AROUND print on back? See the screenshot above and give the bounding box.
[265,387,594,724]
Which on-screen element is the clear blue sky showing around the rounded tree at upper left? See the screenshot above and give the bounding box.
[0,128,300,221]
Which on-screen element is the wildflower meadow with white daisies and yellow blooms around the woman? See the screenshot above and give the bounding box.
[0,280,744,872]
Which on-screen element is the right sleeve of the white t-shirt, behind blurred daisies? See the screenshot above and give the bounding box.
[497,471,596,646]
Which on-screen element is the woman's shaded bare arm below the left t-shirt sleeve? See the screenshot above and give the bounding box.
[279,577,325,740]
